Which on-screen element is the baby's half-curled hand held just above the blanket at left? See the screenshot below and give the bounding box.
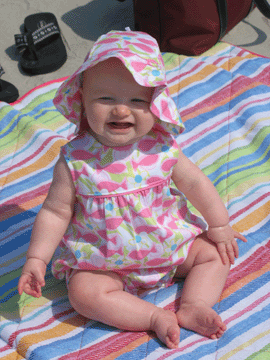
[18,258,47,298]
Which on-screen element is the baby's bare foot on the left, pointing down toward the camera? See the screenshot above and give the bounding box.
[151,308,180,349]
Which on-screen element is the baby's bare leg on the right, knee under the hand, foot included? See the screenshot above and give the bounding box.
[176,234,230,339]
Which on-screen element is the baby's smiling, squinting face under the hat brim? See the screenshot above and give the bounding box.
[82,58,156,147]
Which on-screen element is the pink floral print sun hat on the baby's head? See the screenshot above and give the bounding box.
[53,29,184,135]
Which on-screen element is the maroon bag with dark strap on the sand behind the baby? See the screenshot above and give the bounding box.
[120,0,270,55]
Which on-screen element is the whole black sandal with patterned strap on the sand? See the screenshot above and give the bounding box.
[15,13,67,75]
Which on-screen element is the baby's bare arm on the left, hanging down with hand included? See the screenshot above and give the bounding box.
[18,155,75,297]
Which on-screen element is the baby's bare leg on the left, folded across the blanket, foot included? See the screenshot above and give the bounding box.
[68,271,180,348]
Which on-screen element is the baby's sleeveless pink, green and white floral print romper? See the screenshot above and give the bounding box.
[52,124,206,294]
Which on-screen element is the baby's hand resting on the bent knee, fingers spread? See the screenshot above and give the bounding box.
[207,224,247,264]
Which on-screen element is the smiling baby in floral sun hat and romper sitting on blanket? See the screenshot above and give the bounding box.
[18,30,246,348]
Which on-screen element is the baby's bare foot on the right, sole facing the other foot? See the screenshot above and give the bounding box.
[176,302,227,340]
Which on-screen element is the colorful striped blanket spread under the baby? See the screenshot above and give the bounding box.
[0,43,270,360]
